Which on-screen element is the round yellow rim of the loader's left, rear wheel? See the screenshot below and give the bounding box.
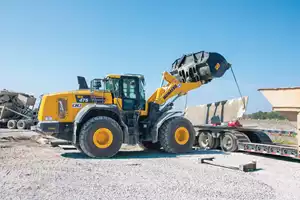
[93,128,113,149]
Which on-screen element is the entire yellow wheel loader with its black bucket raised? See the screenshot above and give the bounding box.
[37,51,231,158]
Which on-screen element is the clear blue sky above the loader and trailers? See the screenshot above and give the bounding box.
[0,0,300,112]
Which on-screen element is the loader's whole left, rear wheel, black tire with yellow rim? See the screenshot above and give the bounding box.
[79,116,123,158]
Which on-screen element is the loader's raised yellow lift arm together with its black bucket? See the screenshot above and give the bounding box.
[141,51,231,115]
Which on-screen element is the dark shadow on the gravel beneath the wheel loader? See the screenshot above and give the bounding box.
[61,150,225,160]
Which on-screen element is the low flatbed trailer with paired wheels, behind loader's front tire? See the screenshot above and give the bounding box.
[194,125,300,159]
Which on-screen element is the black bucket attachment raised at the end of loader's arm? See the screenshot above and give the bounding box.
[171,51,231,84]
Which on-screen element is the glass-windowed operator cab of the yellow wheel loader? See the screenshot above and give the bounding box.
[105,74,146,111]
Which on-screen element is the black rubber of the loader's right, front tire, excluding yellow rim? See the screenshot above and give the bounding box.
[159,117,195,153]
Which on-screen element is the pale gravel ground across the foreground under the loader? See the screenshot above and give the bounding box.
[0,135,300,200]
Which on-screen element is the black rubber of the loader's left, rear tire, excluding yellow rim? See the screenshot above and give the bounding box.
[79,116,123,158]
